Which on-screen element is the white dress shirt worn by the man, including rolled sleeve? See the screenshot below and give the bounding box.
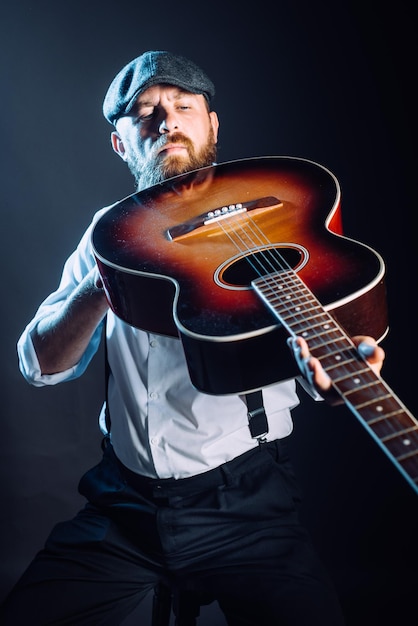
[17,207,299,478]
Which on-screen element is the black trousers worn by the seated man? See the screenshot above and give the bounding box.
[0,441,343,626]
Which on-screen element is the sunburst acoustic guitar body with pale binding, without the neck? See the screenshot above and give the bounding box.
[92,157,387,394]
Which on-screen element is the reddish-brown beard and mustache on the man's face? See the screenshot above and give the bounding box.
[126,128,216,191]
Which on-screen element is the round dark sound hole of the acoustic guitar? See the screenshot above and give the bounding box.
[222,247,302,288]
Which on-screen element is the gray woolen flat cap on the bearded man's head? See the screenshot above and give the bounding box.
[103,50,215,124]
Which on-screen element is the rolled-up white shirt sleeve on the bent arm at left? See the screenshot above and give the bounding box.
[17,207,109,387]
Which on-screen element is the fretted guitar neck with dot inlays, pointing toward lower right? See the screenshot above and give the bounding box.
[252,270,418,493]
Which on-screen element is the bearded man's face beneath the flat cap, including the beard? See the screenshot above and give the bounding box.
[112,85,219,190]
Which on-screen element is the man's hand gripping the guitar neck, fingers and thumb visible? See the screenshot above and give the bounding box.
[289,335,385,404]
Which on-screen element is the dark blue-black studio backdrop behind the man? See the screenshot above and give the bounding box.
[0,0,418,626]
